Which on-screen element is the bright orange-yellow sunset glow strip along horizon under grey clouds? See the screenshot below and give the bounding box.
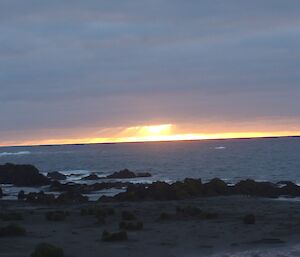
[0,124,300,146]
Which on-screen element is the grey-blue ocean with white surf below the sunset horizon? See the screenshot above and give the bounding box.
[0,137,300,198]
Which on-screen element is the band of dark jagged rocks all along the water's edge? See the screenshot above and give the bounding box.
[0,164,300,204]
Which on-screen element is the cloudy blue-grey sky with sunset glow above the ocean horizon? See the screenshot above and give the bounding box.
[0,0,300,145]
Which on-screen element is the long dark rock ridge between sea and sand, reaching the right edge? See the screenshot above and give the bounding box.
[99,178,300,201]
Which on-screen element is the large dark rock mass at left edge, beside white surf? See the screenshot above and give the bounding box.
[0,163,50,186]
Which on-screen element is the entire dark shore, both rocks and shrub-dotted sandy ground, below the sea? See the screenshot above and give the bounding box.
[0,164,300,257]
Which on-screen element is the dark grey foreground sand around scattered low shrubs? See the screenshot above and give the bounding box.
[0,196,300,257]
